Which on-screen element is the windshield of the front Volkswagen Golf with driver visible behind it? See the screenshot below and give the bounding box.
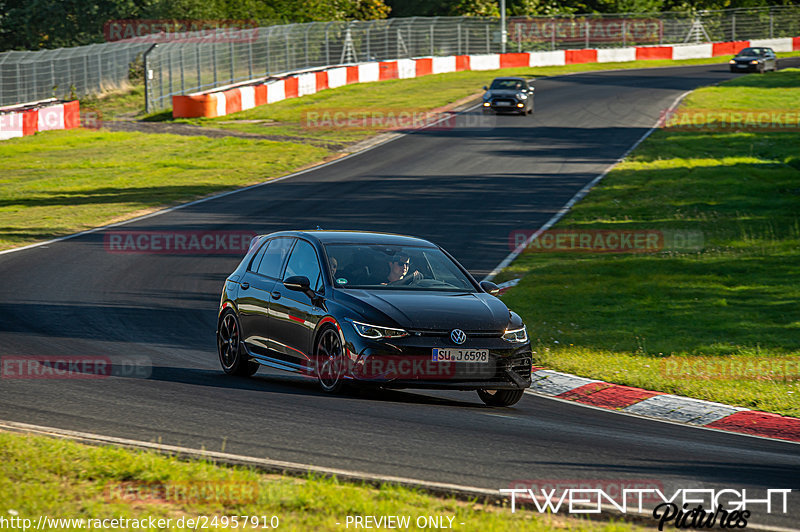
[325,244,476,292]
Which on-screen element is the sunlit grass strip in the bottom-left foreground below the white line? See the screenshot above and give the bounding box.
[0,433,636,532]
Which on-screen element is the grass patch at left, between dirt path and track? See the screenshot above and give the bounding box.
[0,129,327,249]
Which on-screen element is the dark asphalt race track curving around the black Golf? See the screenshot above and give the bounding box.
[0,60,800,527]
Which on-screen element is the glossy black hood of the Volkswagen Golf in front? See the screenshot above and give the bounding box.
[334,290,510,331]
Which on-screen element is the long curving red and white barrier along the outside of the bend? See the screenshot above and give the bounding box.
[172,37,800,118]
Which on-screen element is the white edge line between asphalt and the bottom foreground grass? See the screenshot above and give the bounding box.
[0,420,800,532]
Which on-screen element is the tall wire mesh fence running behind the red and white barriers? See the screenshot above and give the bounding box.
[0,6,800,112]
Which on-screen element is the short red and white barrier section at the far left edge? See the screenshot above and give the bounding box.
[0,100,80,140]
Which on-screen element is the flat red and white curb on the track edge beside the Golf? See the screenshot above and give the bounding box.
[530,367,800,442]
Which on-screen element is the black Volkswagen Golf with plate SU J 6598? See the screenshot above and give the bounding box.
[217,230,531,406]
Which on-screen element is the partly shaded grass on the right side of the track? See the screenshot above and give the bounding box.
[498,69,800,416]
